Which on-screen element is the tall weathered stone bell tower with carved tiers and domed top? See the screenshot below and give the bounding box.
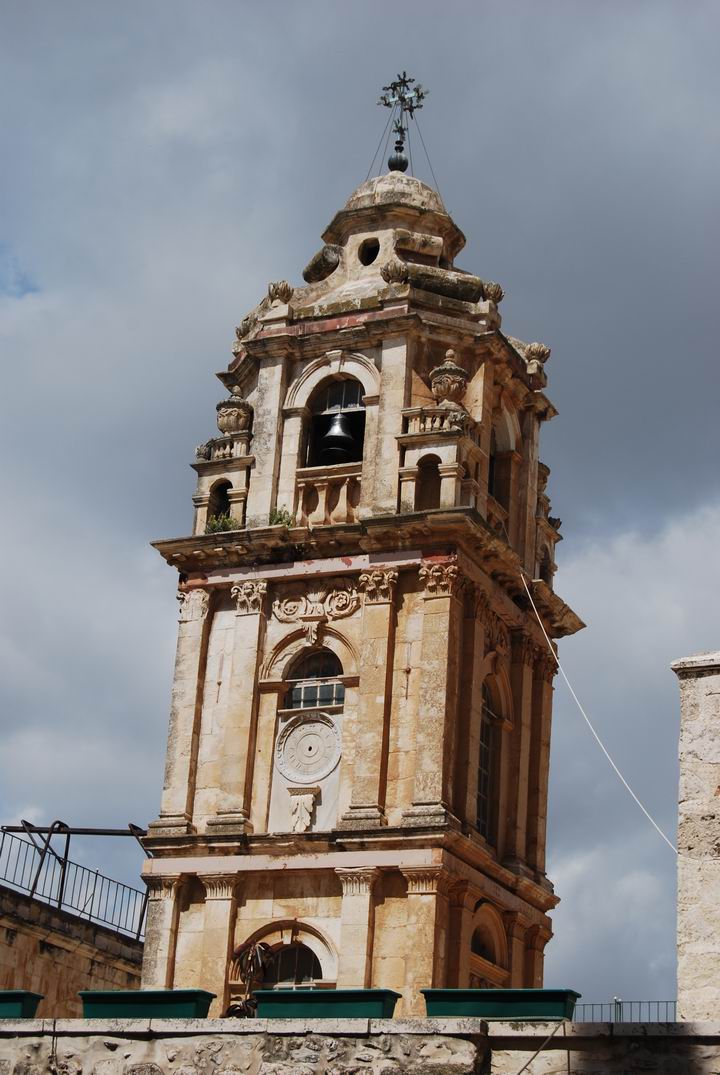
[143,134,582,1015]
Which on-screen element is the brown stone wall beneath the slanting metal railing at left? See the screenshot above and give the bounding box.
[0,886,143,1014]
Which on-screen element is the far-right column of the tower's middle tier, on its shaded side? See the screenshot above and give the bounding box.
[527,648,558,873]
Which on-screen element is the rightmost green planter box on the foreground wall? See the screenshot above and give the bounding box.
[420,989,580,1021]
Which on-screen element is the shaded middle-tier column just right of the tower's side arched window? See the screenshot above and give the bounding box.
[504,630,536,865]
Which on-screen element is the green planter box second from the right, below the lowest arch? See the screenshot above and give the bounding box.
[255,989,400,1019]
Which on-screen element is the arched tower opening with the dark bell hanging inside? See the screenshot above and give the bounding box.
[306,377,365,467]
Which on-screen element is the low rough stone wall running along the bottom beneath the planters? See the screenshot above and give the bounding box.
[0,1019,720,1075]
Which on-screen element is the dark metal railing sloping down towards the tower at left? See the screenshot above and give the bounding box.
[0,827,147,940]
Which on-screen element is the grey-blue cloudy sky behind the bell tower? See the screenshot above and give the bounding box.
[0,0,720,1000]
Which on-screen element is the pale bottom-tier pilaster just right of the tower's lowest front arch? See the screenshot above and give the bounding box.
[335,866,379,989]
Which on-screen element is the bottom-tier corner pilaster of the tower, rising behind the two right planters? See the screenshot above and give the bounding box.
[402,866,449,1017]
